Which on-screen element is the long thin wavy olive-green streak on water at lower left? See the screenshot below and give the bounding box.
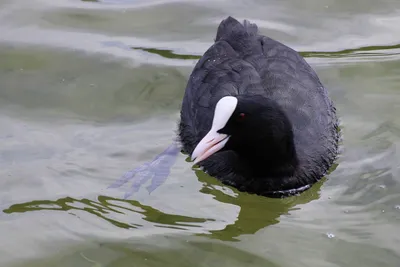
[3,196,214,230]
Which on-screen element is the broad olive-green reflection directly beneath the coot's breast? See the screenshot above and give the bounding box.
[196,171,326,241]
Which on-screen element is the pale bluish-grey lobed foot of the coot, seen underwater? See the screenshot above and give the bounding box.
[108,142,180,199]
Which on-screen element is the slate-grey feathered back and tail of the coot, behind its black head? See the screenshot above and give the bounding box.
[180,17,339,184]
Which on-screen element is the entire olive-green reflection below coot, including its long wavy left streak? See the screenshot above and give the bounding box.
[3,170,324,241]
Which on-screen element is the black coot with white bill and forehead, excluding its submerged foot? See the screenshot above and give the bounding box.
[179,17,340,197]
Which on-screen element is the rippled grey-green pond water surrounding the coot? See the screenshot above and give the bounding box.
[0,0,400,267]
